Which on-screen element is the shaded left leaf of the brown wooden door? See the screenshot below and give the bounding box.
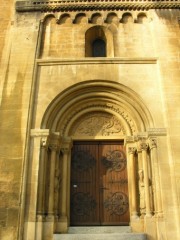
[71,143,99,225]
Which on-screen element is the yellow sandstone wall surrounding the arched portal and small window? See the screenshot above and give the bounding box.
[0,1,180,240]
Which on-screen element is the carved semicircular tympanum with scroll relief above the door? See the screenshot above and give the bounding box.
[73,113,125,136]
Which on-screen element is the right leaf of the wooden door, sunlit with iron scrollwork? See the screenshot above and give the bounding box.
[99,143,129,225]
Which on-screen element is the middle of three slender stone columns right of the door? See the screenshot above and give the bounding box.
[140,142,152,217]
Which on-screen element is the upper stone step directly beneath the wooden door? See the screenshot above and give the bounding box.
[68,226,131,234]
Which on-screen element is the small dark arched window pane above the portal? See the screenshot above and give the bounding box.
[92,39,106,57]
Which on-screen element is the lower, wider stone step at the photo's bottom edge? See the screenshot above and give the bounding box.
[54,233,147,240]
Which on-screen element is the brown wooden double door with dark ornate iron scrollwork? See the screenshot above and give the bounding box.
[70,141,129,226]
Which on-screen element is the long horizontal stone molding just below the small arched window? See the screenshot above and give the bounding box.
[36,57,158,66]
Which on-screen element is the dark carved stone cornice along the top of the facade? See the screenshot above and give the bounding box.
[16,0,180,12]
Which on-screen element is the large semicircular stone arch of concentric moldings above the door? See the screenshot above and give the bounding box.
[41,80,154,136]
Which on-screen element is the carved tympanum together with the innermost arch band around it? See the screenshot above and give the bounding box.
[60,103,137,136]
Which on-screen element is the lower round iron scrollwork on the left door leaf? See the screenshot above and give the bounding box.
[71,192,96,216]
